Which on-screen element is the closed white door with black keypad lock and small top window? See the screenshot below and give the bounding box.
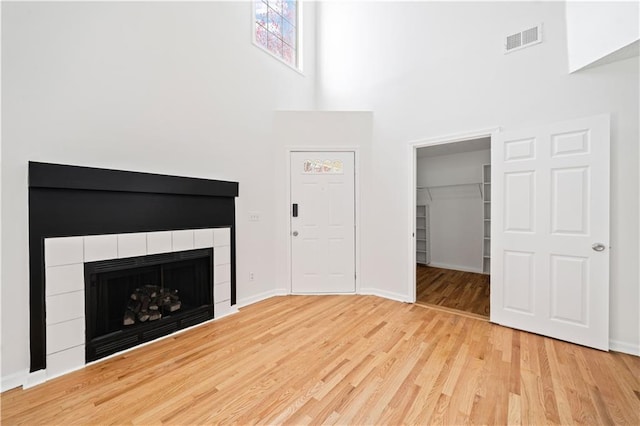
[290,152,355,294]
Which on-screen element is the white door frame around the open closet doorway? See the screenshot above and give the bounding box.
[407,126,500,303]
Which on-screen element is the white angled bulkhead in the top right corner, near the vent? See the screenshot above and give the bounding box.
[566,0,640,72]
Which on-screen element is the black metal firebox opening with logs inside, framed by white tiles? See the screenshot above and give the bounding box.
[85,248,214,361]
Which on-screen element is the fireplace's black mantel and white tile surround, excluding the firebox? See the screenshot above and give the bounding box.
[24,162,238,387]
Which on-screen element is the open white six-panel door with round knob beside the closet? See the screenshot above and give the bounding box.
[491,116,609,350]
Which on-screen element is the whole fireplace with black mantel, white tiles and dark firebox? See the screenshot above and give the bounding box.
[29,162,238,382]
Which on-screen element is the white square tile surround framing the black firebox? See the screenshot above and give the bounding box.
[44,228,236,380]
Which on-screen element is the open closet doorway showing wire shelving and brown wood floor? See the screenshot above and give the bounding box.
[415,136,491,319]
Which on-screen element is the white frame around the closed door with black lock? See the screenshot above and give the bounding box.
[285,146,360,295]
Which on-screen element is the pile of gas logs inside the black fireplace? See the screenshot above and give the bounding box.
[122,285,182,325]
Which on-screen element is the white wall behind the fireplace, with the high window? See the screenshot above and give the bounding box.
[1,2,315,385]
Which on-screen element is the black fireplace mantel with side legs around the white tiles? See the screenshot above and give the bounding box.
[29,162,238,372]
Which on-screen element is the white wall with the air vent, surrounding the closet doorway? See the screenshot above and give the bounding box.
[318,2,640,352]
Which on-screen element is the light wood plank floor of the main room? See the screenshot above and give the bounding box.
[1,296,640,425]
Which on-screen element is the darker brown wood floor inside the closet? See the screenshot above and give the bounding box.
[416,265,489,318]
